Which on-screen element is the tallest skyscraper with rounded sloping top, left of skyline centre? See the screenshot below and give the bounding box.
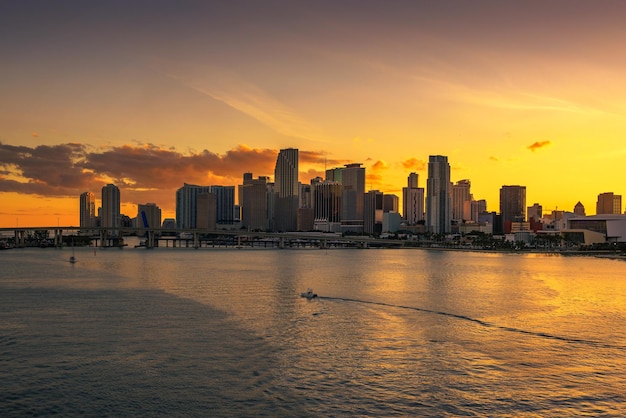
[274,148,299,231]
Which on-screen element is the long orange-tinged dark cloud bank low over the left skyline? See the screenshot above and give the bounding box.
[0,142,332,212]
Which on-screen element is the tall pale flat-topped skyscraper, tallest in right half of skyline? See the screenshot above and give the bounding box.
[426,155,452,234]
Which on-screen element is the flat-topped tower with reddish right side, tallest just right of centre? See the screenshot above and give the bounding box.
[341,163,365,233]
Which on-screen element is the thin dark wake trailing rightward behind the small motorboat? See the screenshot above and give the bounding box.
[319,296,626,351]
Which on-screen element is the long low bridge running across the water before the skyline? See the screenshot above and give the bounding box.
[0,226,407,248]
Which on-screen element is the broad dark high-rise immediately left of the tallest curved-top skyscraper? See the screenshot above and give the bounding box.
[240,173,269,231]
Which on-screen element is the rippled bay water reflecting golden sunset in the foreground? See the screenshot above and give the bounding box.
[0,248,626,416]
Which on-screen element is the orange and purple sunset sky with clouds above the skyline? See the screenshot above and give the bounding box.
[0,0,626,227]
